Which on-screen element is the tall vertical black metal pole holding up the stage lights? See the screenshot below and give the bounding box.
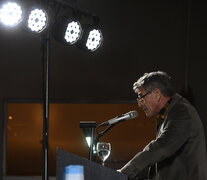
[42,29,50,180]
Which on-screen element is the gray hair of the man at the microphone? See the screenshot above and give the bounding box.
[133,71,174,97]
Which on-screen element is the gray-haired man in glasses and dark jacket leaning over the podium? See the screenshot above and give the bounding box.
[119,71,207,180]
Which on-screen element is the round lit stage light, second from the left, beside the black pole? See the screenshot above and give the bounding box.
[28,9,48,33]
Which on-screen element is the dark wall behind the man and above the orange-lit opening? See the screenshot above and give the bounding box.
[0,0,207,177]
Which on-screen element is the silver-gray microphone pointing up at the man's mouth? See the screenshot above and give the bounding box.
[106,110,138,124]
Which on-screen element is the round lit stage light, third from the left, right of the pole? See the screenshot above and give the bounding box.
[64,21,82,44]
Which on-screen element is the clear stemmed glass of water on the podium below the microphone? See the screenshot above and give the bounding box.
[96,142,111,166]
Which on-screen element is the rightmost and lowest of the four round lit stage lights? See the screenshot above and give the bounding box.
[86,29,103,51]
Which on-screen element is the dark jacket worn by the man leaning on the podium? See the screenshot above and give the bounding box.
[121,94,207,180]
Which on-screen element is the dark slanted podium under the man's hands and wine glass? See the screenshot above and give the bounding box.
[56,149,128,180]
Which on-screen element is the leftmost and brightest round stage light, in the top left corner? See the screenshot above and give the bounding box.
[0,2,22,26]
